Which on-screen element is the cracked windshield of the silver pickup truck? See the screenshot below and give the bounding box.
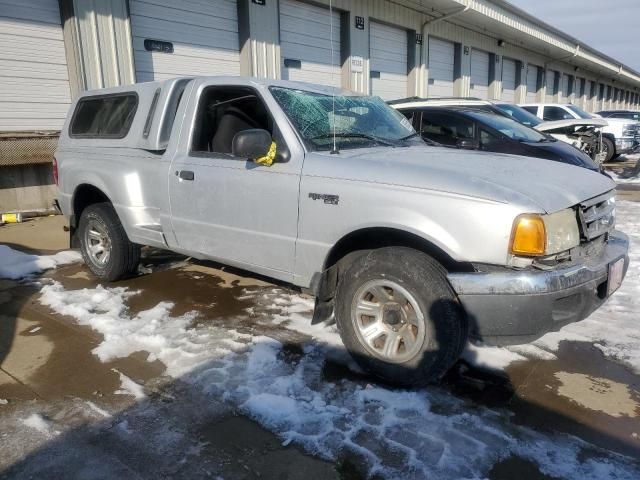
[271,87,416,150]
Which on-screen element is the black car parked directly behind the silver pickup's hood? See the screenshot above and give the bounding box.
[392,101,600,171]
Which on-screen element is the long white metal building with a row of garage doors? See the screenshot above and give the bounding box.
[0,0,640,211]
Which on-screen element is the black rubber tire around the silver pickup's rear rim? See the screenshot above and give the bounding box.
[78,202,140,282]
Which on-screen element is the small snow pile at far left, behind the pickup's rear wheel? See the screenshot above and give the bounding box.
[0,245,82,280]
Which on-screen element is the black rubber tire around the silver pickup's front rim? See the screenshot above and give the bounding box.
[335,247,468,386]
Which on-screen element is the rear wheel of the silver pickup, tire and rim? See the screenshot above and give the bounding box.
[78,202,140,282]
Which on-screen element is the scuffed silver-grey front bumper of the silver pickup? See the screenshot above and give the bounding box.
[448,231,629,345]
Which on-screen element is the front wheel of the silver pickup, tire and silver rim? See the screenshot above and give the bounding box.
[336,247,467,386]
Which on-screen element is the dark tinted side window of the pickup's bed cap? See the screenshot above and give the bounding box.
[69,92,138,138]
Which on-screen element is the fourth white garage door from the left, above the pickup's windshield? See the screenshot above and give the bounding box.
[369,22,407,100]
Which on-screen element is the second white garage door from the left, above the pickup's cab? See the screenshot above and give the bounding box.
[129,0,240,82]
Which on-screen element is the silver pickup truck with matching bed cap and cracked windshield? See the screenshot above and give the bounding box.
[54,77,629,384]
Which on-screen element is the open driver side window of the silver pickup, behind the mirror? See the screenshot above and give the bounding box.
[191,87,273,158]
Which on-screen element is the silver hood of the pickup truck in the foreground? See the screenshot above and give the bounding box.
[304,145,615,213]
